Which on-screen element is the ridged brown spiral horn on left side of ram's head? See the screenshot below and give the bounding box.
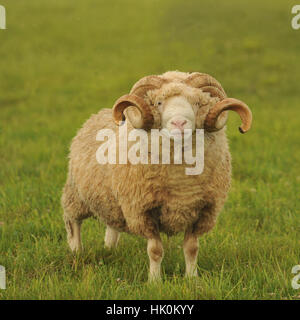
[113,76,165,130]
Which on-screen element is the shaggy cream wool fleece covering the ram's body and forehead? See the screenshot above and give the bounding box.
[62,71,252,276]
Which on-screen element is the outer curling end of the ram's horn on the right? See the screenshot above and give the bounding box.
[204,98,252,133]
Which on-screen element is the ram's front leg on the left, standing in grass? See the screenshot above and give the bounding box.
[147,236,164,281]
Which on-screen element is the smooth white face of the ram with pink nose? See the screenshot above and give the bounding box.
[156,96,196,134]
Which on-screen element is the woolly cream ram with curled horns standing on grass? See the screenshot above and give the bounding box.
[62,71,252,281]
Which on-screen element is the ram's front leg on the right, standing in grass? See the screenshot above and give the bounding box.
[183,229,199,277]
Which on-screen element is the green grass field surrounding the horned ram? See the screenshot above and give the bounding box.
[0,0,300,299]
